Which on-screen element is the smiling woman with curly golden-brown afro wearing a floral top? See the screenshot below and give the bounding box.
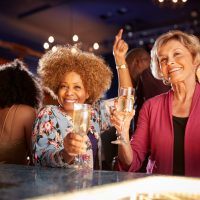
[33,46,115,169]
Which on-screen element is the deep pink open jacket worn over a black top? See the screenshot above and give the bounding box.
[119,84,200,177]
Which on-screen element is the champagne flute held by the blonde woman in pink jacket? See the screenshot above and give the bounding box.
[111,87,135,144]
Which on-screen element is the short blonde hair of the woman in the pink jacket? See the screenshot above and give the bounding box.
[151,30,200,79]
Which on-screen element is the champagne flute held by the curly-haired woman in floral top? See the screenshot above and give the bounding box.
[73,103,91,169]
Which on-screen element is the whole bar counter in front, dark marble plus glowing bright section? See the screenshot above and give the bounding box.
[0,164,200,200]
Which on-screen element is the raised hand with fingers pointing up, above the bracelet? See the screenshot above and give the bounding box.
[113,29,128,65]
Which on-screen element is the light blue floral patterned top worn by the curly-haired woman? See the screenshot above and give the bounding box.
[32,101,110,168]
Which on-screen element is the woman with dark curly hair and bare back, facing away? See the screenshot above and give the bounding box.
[0,60,42,164]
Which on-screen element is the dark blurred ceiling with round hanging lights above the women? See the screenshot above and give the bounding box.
[0,0,200,97]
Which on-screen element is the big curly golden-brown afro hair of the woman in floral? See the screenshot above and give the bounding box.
[38,45,112,104]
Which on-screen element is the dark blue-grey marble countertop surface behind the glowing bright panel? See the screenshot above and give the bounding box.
[0,164,147,200]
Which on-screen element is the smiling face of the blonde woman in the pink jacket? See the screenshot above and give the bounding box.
[158,40,196,84]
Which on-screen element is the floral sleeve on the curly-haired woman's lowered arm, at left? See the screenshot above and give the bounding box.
[32,106,65,167]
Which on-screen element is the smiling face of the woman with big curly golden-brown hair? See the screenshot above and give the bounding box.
[57,72,89,115]
